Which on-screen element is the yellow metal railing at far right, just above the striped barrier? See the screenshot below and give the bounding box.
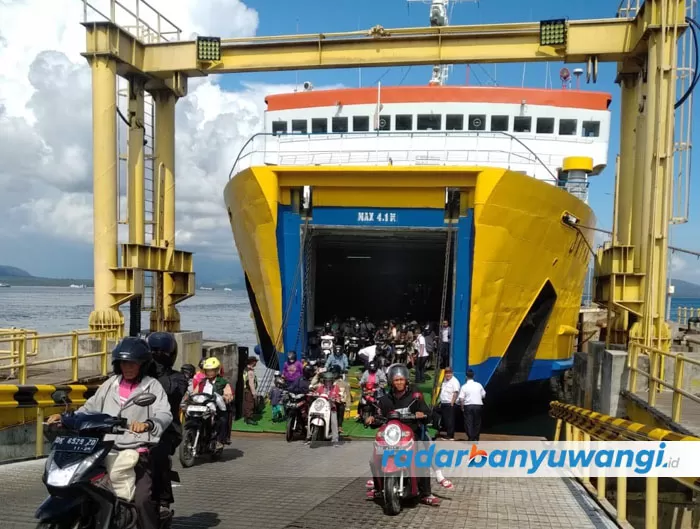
[627,342,700,423]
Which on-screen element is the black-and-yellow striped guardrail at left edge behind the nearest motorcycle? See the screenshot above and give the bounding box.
[0,384,98,457]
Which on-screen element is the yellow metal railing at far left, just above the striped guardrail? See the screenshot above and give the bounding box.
[0,328,122,385]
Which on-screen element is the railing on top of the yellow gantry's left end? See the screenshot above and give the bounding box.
[82,0,182,44]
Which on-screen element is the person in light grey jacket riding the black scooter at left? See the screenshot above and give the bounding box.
[47,336,173,529]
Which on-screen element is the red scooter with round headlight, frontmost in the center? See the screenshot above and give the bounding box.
[370,392,427,516]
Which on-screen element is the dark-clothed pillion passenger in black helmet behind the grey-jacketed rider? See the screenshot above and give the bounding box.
[147,332,188,514]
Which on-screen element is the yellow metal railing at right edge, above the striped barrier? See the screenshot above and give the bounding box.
[627,342,700,424]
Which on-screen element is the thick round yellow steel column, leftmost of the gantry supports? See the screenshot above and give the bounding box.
[89,56,124,329]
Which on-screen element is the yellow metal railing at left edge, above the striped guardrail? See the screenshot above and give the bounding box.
[0,328,122,384]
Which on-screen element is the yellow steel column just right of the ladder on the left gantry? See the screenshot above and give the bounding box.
[154,91,180,332]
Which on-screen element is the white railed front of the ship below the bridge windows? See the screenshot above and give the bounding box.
[229,131,594,183]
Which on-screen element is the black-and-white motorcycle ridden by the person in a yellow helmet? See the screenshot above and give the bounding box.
[180,393,223,468]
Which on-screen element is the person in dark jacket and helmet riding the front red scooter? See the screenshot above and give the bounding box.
[365,364,440,505]
